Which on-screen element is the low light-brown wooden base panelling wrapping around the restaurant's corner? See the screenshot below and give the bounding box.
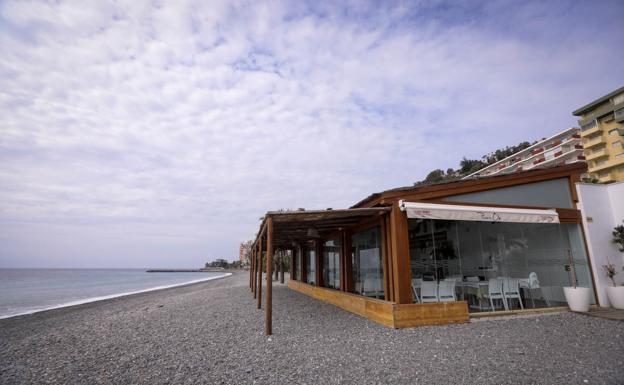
[288,280,469,328]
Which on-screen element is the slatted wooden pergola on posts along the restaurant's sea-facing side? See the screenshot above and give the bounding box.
[249,207,390,335]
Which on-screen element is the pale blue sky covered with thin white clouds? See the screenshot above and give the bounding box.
[0,0,624,267]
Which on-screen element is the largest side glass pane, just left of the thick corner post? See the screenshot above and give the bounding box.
[351,226,384,298]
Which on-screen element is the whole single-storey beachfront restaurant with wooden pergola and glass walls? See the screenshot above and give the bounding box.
[249,163,594,334]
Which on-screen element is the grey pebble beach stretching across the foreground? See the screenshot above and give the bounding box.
[0,272,624,384]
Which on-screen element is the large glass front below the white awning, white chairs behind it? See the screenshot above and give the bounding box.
[408,219,591,311]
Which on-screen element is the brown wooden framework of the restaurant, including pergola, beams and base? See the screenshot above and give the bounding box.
[249,164,587,335]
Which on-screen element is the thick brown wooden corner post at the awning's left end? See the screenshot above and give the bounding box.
[390,201,412,303]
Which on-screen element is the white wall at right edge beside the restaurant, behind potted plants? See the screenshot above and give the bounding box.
[576,182,624,306]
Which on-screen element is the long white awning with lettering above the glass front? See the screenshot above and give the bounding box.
[399,201,559,223]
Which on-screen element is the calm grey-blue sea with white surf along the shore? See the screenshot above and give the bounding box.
[0,269,227,318]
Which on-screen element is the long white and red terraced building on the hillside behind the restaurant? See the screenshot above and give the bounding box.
[463,127,585,179]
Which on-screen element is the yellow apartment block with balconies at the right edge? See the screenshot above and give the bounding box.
[572,87,624,183]
